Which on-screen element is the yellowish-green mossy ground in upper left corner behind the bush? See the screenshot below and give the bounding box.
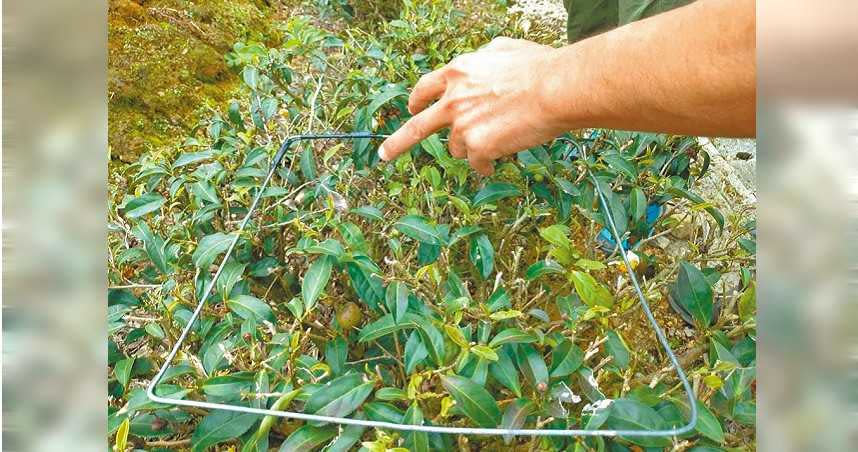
[108,0,281,162]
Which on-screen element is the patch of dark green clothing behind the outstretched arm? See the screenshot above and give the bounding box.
[563,0,693,42]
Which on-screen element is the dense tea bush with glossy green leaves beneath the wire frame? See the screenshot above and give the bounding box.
[108,1,755,451]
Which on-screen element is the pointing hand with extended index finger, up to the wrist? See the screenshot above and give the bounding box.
[378,38,566,176]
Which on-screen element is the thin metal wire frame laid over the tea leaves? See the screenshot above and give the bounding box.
[146,132,697,437]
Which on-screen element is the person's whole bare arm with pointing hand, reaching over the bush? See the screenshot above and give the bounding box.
[379,0,756,175]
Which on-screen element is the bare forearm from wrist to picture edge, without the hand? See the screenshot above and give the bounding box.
[538,0,756,136]
